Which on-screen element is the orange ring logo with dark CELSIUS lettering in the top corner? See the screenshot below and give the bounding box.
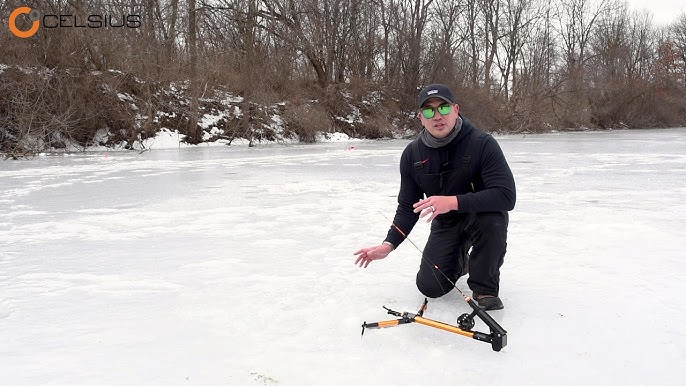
[8,7,142,39]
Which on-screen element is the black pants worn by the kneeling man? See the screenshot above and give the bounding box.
[417,212,509,298]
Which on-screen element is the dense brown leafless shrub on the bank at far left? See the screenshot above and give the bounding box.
[0,67,157,153]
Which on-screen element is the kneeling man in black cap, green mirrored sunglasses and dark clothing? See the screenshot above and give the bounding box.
[354,84,516,310]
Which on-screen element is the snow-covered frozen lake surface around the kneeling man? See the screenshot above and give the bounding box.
[0,129,686,385]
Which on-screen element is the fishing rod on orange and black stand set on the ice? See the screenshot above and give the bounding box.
[362,212,507,351]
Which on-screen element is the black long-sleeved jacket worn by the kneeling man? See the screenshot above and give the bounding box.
[386,117,516,248]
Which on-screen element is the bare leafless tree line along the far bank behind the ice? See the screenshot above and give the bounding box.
[0,0,686,154]
